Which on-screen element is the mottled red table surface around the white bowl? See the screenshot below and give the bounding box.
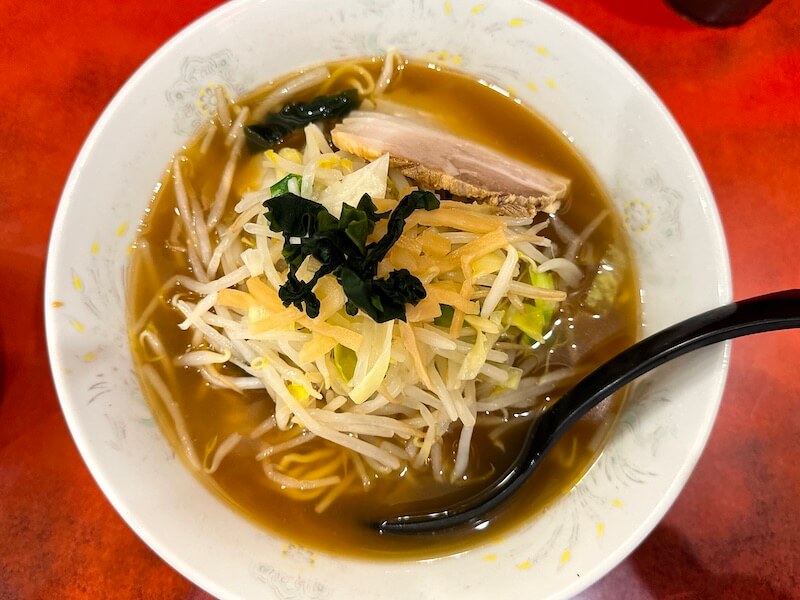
[0,0,800,599]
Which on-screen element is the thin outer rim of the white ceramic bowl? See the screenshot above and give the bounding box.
[44,0,733,598]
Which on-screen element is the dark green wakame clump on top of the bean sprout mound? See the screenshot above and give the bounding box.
[264,191,439,323]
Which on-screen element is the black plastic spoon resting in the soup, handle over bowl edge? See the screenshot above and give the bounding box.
[375,289,800,534]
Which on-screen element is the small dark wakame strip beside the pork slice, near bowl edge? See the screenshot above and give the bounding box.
[244,89,361,152]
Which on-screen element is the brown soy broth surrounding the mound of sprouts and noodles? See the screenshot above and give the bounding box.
[130,61,639,559]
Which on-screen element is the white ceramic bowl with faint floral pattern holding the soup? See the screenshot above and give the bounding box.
[45,0,731,599]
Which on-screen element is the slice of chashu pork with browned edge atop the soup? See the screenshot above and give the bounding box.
[331,110,569,216]
